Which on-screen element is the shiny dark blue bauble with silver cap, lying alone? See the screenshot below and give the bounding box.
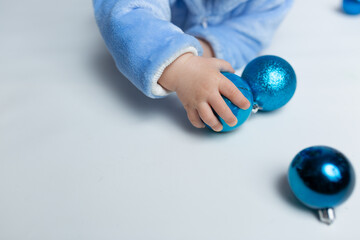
[288,146,355,224]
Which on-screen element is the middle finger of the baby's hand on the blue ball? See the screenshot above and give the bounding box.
[209,94,237,127]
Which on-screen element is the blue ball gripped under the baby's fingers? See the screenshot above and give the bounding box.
[206,72,253,132]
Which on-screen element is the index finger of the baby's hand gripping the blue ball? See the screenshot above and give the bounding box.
[219,77,250,109]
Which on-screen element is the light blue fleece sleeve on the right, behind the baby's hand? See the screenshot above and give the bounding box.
[185,0,293,69]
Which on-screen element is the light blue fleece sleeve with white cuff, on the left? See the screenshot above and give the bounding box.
[93,0,202,98]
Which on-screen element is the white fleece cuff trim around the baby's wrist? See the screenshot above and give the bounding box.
[151,46,198,97]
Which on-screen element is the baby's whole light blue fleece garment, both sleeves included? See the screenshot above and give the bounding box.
[93,0,292,98]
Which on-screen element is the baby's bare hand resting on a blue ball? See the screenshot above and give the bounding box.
[158,53,250,131]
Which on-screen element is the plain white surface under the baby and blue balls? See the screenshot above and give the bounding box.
[0,0,360,240]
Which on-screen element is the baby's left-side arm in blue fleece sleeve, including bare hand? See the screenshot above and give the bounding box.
[94,0,250,131]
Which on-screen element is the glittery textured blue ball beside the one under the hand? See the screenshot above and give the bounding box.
[241,55,296,111]
